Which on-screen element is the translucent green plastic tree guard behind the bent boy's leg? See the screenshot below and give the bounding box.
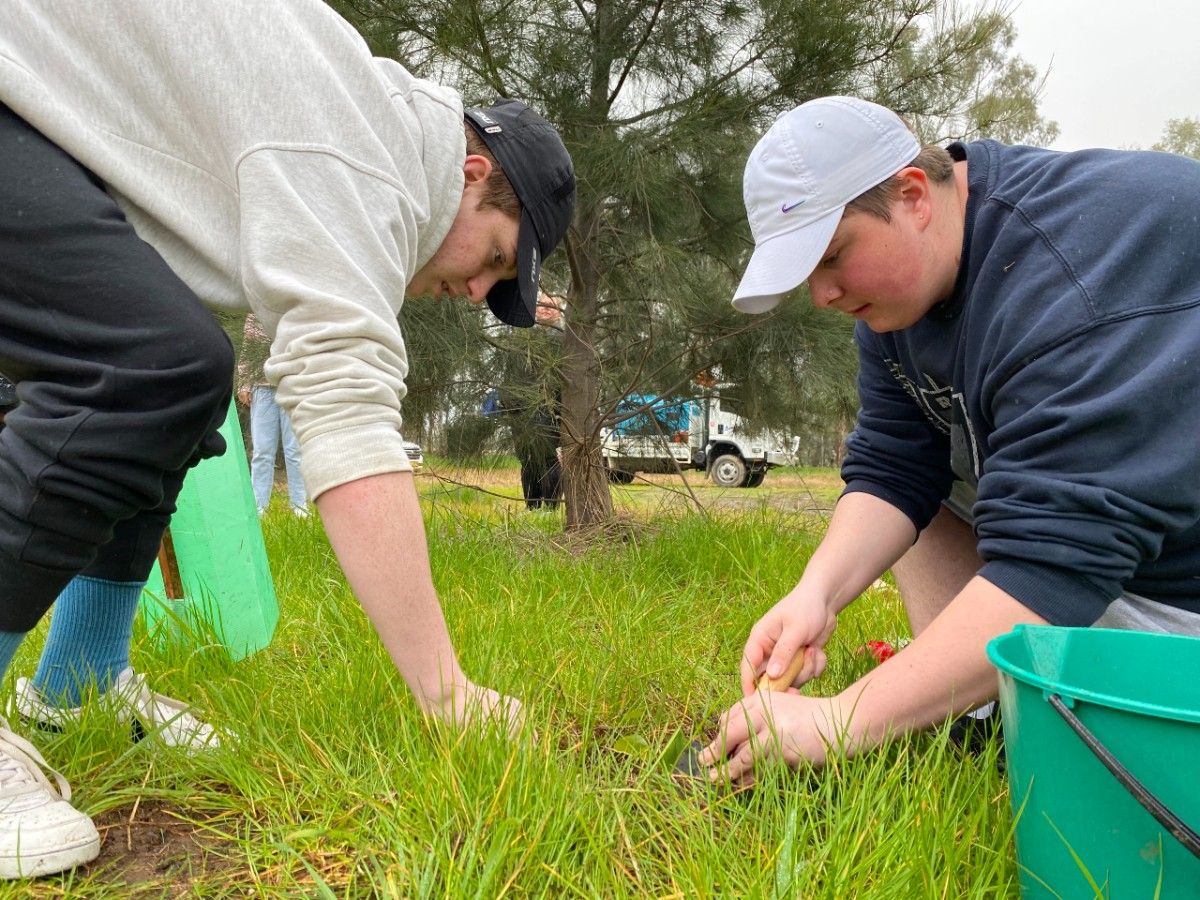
[142,402,280,660]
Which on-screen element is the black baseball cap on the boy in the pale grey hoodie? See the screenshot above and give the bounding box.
[463,97,575,328]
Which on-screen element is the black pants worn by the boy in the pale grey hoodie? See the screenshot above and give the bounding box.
[0,106,234,631]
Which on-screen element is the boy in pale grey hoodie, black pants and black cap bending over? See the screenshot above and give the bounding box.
[0,0,575,877]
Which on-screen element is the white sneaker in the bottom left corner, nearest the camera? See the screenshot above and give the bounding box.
[0,719,100,878]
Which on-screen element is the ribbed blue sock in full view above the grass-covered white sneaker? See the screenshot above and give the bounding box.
[34,575,144,707]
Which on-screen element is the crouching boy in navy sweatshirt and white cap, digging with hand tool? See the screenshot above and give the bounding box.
[702,97,1200,781]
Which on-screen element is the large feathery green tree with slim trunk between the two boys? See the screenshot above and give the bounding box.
[334,0,1054,528]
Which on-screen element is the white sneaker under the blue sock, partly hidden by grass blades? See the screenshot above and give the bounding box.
[14,668,221,752]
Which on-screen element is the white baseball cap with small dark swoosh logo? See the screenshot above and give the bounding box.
[733,97,920,312]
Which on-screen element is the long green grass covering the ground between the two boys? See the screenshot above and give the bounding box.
[0,473,1018,899]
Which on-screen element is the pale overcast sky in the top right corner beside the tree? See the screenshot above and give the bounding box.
[1012,0,1200,150]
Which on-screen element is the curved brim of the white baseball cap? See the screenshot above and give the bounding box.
[733,206,845,312]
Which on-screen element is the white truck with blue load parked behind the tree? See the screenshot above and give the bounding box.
[600,395,796,487]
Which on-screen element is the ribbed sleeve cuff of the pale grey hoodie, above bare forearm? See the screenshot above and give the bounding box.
[300,422,413,499]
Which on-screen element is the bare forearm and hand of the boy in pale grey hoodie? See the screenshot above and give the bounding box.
[317,472,521,733]
